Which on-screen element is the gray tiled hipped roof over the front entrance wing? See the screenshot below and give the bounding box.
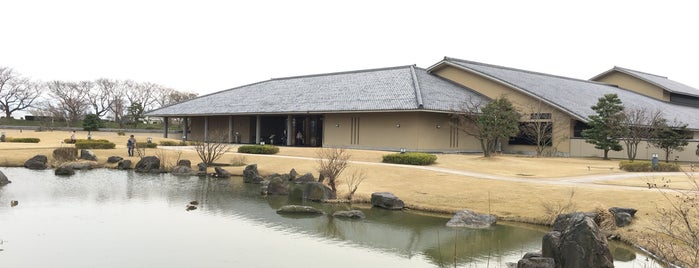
[147,66,484,116]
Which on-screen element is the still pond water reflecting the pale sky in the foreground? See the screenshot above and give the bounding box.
[0,168,656,267]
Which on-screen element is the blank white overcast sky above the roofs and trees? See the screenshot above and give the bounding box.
[0,0,699,94]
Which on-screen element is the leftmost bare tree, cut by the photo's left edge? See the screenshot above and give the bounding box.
[0,67,43,118]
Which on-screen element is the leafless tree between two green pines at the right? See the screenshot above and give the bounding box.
[619,107,662,161]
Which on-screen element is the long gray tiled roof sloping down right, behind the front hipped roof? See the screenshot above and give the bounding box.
[442,58,699,129]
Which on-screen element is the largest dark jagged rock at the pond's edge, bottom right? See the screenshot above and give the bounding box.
[542,213,614,268]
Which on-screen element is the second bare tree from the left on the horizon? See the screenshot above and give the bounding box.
[48,81,89,125]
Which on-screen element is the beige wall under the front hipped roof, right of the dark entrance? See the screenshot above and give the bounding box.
[323,112,480,152]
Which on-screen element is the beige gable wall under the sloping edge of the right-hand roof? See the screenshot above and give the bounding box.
[433,66,574,155]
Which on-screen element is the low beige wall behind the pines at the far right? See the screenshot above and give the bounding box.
[571,139,699,162]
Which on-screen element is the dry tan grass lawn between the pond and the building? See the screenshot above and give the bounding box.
[0,130,688,256]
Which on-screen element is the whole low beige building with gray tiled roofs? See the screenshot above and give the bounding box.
[146,57,699,159]
